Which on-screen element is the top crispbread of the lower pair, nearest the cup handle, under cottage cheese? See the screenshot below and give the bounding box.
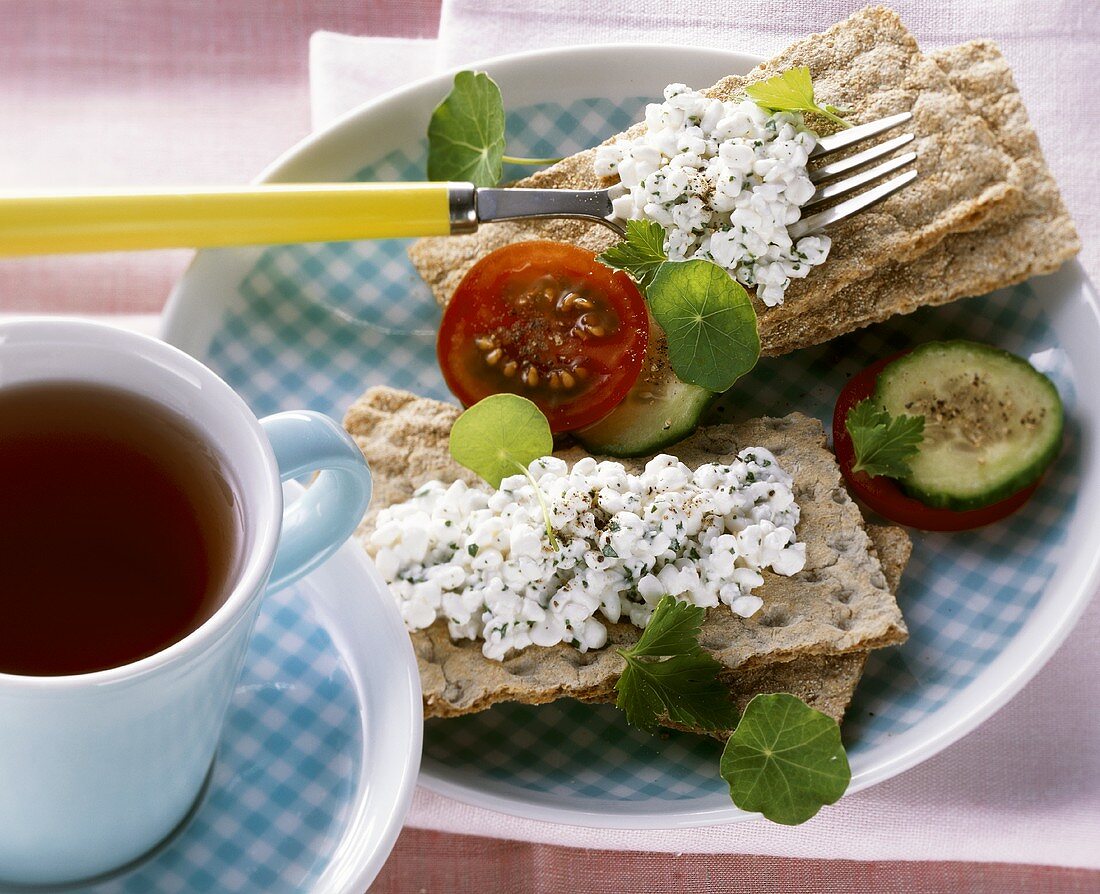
[344,388,905,717]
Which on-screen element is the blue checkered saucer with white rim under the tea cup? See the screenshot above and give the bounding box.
[58,483,422,894]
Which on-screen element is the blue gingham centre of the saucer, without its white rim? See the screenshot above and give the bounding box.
[72,588,362,894]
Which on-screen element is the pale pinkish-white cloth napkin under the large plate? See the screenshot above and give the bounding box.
[310,0,1100,869]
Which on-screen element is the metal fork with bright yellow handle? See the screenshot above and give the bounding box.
[0,112,916,257]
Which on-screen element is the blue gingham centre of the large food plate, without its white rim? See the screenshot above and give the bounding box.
[202,99,1079,810]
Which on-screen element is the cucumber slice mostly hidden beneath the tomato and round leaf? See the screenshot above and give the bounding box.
[573,339,717,456]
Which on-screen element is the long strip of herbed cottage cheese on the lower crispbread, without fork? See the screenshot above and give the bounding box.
[367,448,805,660]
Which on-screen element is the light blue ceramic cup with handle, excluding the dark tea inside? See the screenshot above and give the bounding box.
[0,320,371,885]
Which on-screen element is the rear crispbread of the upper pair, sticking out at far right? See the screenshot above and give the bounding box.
[765,41,1081,354]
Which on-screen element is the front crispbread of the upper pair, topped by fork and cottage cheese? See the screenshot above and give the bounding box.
[409,7,1021,354]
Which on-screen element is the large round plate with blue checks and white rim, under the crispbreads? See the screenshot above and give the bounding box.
[167,46,1100,828]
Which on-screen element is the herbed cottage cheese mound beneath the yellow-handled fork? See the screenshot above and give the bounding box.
[595,84,831,307]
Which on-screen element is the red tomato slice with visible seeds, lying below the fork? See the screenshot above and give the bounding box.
[436,242,649,432]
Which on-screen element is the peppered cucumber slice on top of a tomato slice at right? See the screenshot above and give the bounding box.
[875,341,1064,511]
